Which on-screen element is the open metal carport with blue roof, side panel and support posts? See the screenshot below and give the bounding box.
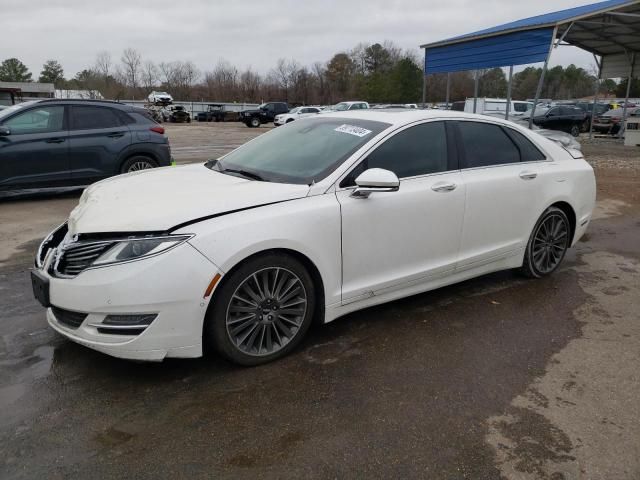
[420,0,640,135]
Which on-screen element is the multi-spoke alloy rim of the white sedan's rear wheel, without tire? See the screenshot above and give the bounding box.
[531,213,569,274]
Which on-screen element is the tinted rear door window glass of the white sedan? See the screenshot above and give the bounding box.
[458,122,520,168]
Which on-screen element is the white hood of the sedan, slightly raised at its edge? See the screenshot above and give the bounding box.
[68,164,309,235]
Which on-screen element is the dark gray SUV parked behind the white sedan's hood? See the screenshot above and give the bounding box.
[0,99,172,194]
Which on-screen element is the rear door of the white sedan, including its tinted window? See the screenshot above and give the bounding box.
[457,121,546,270]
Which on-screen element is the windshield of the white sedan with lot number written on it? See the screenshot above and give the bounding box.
[207,117,390,185]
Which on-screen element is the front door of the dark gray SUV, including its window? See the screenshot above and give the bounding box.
[0,104,72,189]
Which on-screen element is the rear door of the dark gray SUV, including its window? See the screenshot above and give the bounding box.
[69,105,131,185]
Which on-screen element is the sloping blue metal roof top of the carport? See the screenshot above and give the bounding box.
[421,0,636,48]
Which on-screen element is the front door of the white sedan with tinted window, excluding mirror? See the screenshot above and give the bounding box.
[336,121,465,304]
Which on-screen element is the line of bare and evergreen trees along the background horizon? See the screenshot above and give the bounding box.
[0,41,640,105]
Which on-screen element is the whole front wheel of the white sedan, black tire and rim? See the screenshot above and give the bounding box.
[204,253,316,366]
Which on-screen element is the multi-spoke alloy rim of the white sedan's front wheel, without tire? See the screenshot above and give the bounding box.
[226,267,307,356]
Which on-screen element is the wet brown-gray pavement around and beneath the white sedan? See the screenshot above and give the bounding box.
[0,132,640,480]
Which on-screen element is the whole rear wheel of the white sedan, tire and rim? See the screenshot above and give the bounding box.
[520,207,571,278]
